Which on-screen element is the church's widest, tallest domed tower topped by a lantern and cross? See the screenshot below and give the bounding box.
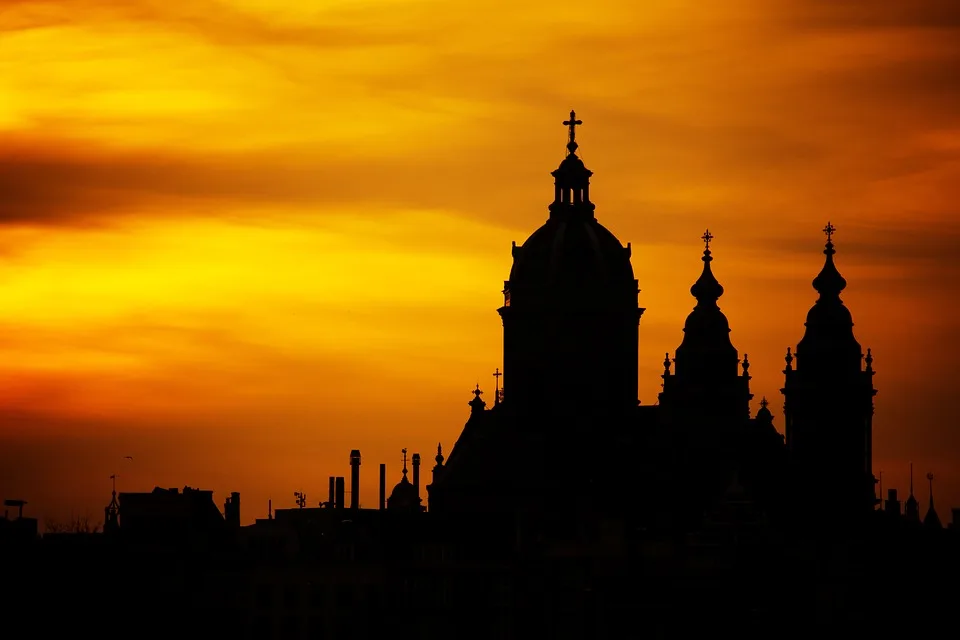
[498,111,644,416]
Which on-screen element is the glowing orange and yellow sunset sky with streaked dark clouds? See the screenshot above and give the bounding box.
[0,0,960,521]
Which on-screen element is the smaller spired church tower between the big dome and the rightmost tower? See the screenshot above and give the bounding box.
[660,229,753,430]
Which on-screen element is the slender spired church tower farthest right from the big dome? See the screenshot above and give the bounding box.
[781,222,877,516]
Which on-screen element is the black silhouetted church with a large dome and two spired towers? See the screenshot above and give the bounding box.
[428,112,876,530]
